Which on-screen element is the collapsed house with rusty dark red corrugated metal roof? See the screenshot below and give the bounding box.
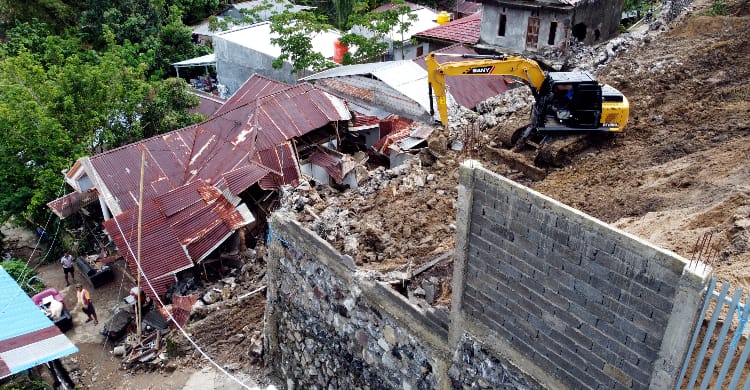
[48,75,351,296]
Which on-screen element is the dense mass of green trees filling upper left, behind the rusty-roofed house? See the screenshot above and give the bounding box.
[0,4,209,227]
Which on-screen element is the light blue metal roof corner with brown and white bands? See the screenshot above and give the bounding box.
[0,265,78,378]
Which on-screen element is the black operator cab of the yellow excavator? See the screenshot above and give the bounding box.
[535,72,606,133]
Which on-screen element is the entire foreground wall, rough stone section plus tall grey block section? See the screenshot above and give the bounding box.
[265,161,710,389]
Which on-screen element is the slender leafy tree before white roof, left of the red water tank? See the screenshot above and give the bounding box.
[271,11,335,73]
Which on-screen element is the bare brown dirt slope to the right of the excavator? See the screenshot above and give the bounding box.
[533,1,750,285]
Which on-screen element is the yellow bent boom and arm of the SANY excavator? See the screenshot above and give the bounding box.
[425,53,546,128]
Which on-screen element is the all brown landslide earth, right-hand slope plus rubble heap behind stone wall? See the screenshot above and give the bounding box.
[284,0,750,294]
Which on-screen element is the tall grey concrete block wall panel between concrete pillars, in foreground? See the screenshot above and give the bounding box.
[450,161,708,389]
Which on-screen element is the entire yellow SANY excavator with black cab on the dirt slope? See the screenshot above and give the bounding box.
[426,53,630,165]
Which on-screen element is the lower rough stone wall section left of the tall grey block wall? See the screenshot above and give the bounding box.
[264,213,450,389]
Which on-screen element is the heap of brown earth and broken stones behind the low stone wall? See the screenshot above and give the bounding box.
[281,159,457,271]
